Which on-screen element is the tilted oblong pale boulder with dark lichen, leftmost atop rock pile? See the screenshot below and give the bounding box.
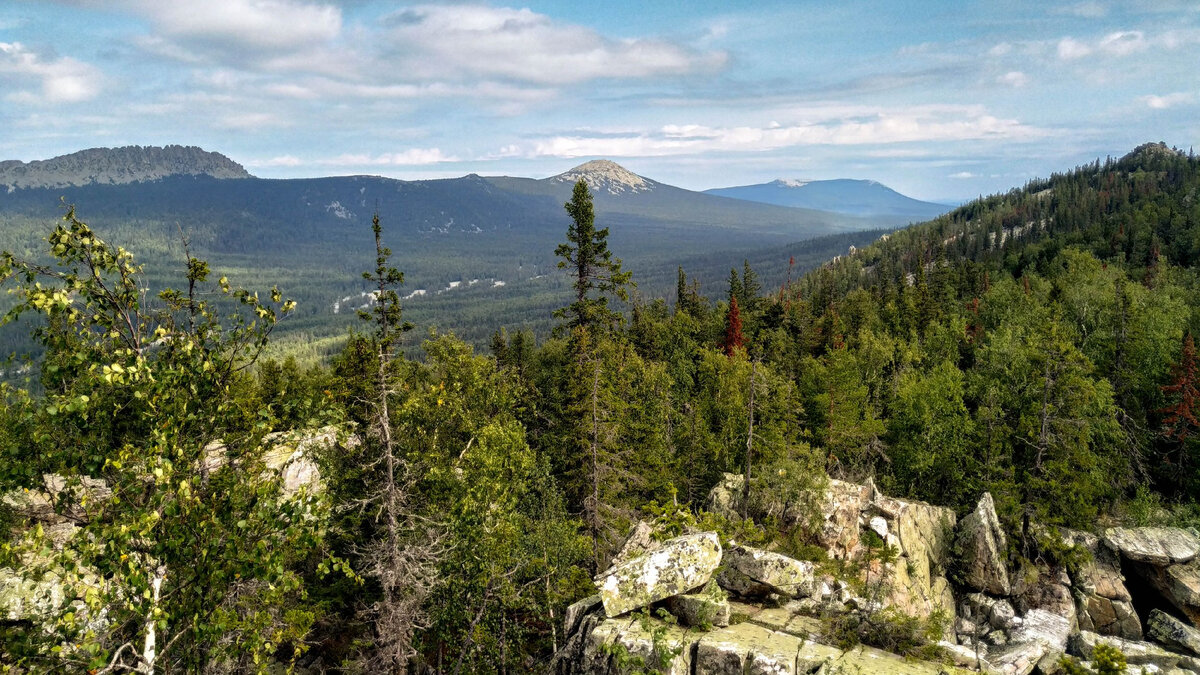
[596,532,721,617]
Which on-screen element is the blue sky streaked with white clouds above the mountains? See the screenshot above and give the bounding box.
[0,0,1200,201]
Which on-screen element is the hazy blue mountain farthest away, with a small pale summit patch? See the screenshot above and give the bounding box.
[704,178,950,223]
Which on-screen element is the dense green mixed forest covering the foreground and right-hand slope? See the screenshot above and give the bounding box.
[0,145,1200,673]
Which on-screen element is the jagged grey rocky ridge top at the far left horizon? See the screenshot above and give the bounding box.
[0,145,251,191]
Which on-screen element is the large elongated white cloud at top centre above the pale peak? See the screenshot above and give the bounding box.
[389,5,726,85]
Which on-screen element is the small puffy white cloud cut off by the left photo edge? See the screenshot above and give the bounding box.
[0,42,103,103]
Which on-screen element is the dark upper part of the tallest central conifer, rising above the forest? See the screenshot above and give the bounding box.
[554,180,634,330]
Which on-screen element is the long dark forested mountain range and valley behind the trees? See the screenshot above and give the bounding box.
[0,148,880,353]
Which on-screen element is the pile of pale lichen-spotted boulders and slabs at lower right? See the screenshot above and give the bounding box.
[552,474,1200,675]
